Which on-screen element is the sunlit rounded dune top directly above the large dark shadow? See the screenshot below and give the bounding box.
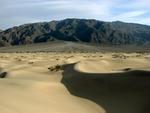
[75,59,150,73]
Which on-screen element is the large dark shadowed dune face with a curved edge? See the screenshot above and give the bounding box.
[61,64,150,113]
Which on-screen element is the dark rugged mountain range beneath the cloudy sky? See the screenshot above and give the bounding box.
[0,19,150,47]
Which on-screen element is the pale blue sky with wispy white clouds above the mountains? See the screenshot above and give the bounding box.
[0,0,150,29]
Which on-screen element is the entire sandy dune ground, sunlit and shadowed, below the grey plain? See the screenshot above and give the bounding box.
[0,52,150,113]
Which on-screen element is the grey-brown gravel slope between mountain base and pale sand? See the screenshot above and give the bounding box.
[0,41,150,53]
